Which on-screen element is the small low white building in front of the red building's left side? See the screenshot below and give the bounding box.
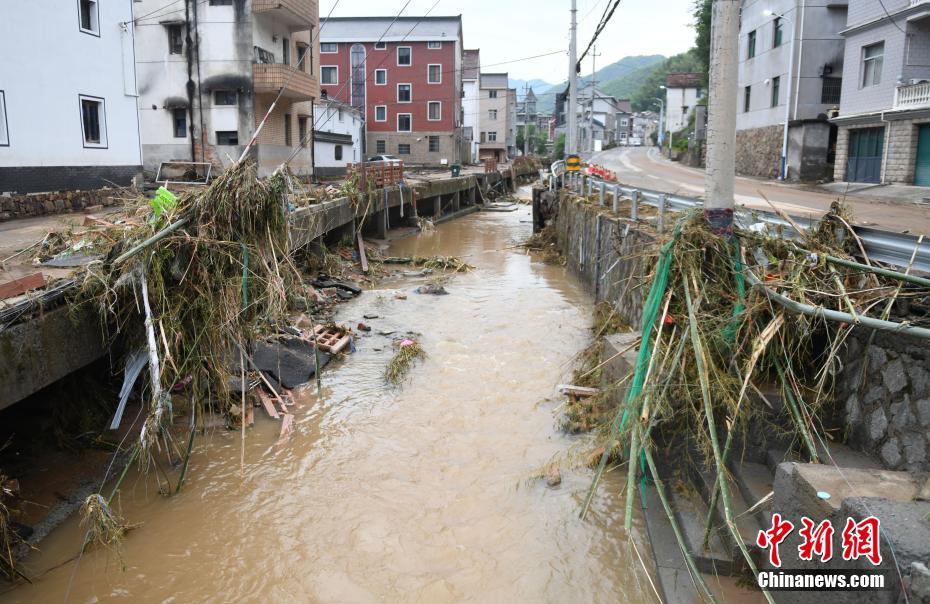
[313,99,364,176]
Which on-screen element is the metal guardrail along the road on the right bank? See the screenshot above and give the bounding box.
[565,173,930,273]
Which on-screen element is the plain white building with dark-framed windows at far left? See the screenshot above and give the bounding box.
[0,0,142,193]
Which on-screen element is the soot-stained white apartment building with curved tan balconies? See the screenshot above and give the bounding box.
[132,0,319,175]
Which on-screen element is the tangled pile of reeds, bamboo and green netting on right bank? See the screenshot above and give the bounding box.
[582,206,930,595]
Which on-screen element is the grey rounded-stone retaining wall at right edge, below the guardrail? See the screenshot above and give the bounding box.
[837,329,930,471]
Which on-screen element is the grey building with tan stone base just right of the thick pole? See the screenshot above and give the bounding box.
[736,0,844,179]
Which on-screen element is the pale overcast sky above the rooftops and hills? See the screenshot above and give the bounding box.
[320,0,694,83]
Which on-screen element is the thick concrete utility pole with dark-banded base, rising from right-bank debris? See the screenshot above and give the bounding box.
[704,0,740,233]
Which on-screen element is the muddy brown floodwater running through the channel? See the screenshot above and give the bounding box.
[0,199,656,603]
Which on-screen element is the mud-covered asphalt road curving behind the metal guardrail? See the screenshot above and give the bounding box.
[591,147,930,235]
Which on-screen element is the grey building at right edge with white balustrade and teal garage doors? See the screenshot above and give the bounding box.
[832,0,930,186]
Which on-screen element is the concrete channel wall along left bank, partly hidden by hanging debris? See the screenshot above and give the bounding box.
[0,166,536,410]
